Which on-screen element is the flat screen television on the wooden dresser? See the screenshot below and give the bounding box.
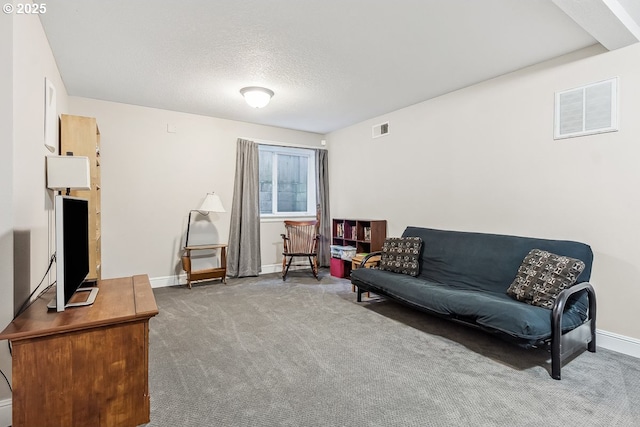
[47,195,98,311]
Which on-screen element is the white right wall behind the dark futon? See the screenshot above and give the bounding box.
[327,44,640,339]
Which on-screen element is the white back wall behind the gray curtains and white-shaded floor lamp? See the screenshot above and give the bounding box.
[69,97,323,281]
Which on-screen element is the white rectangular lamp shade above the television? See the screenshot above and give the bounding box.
[47,156,91,190]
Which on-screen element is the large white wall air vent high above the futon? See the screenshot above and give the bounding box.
[553,78,618,139]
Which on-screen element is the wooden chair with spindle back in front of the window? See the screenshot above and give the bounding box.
[280,220,320,281]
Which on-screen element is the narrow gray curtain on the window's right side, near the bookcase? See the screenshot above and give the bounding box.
[316,149,331,267]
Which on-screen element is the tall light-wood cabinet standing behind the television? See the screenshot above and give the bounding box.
[60,114,102,281]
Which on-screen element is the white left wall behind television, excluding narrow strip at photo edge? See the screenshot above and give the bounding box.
[13,2,67,306]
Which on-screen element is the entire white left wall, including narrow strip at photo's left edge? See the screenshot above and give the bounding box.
[0,8,67,422]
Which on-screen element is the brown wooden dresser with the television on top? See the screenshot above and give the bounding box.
[0,275,158,427]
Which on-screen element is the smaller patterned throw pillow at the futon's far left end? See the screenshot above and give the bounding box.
[380,237,422,277]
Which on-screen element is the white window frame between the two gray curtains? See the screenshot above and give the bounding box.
[258,143,317,219]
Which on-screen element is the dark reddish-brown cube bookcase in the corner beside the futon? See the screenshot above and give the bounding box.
[331,218,387,253]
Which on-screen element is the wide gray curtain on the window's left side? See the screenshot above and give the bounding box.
[227,139,262,277]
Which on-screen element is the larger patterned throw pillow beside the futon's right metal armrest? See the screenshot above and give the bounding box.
[507,249,584,308]
